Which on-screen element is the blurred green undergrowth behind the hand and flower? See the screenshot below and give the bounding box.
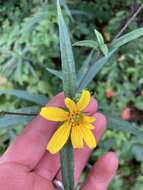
[0,0,143,190]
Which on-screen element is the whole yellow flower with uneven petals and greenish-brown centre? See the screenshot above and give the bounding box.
[40,90,96,154]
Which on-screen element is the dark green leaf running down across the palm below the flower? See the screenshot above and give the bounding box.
[60,140,74,190]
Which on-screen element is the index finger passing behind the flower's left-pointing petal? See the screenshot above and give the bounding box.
[0,93,95,170]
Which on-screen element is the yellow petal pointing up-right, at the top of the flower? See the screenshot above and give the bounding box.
[77,90,90,111]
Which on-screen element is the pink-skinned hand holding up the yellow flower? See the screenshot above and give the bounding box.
[0,93,118,190]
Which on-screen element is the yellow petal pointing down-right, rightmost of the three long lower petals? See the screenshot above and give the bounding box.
[80,125,96,149]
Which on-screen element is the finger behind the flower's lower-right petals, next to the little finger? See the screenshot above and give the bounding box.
[56,112,107,184]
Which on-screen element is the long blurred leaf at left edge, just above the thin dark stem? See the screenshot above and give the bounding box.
[0,90,48,105]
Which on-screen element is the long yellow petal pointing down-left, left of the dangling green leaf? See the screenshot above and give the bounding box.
[47,122,71,154]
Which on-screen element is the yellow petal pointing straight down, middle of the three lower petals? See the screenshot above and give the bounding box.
[71,126,83,148]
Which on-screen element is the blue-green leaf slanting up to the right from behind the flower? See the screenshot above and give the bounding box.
[78,49,116,90]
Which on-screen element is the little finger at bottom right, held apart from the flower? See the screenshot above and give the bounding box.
[82,152,118,190]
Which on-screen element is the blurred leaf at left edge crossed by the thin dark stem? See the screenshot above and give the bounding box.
[0,106,39,128]
